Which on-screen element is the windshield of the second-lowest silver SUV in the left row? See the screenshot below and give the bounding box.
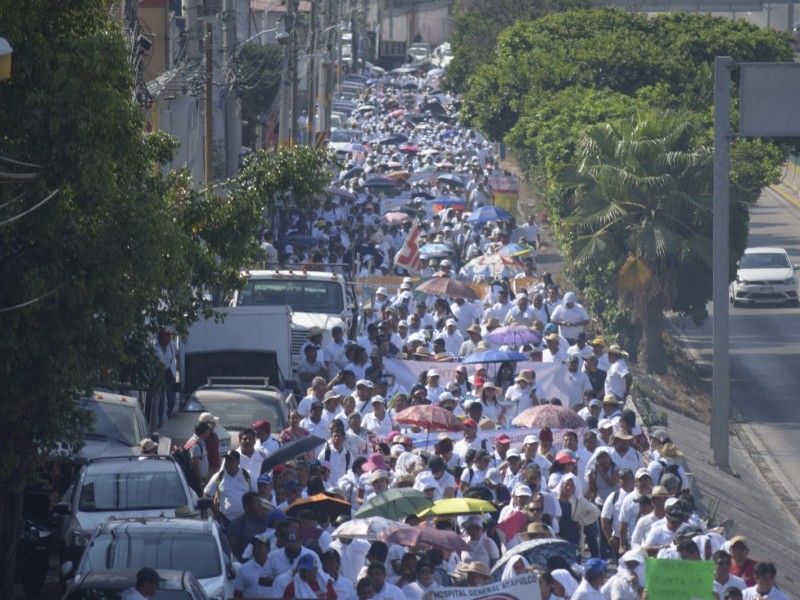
[79,471,188,512]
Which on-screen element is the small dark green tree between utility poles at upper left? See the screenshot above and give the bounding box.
[236,43,283,148]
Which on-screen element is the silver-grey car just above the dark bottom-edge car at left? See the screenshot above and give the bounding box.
[62,517,233,600]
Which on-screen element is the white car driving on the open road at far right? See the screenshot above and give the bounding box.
[729,247,800,307]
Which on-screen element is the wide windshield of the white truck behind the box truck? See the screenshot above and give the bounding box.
[238,278,344,315]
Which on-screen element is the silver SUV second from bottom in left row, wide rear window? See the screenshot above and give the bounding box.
[53,455,211,565]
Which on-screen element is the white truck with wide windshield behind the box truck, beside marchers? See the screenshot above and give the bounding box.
[231,269,353,368]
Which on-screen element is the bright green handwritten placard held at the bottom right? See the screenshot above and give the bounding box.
[645,558,714,600]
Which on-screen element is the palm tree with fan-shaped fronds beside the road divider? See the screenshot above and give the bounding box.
[559,111,713,373]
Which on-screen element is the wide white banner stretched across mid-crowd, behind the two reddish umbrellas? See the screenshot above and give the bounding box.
[383,358,569,406]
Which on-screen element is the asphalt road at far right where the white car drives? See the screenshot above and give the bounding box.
[675,186,800,500]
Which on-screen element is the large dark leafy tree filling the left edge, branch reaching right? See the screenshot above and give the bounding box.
[0,0,323,598]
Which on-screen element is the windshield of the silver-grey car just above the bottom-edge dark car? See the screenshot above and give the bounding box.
[80,527,223,579]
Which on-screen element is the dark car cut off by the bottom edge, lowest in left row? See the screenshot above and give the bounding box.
[62,569,208,600]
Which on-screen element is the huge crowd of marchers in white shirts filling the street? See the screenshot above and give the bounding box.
[134,65,786,600]
